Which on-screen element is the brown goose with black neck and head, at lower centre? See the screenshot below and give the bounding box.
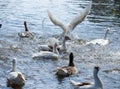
[56,52,77,77]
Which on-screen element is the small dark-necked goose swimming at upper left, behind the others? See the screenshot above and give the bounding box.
[18,21,34,38]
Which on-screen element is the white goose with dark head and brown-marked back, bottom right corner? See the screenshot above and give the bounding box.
[71,66,103,89]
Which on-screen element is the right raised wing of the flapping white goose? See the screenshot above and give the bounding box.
[69,1,92,31]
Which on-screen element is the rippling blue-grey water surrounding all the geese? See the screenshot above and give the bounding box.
[0,0,120,89]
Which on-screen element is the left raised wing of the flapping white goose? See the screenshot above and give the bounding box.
[47,10,66,32]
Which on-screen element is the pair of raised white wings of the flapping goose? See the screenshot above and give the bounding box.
[47,1,92,38]
